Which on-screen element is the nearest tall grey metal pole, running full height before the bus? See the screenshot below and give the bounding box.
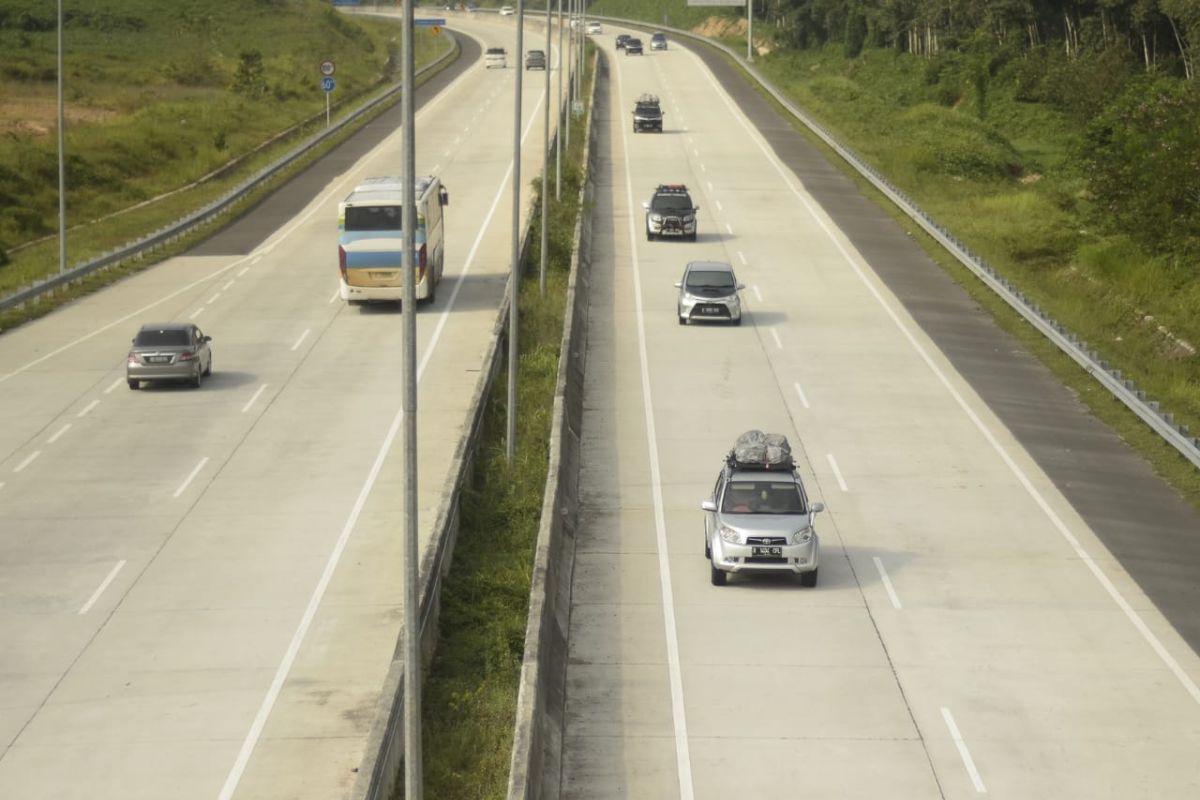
[400,0,420,800]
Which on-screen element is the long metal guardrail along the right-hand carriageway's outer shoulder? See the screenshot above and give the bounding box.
[590,17,1200,468]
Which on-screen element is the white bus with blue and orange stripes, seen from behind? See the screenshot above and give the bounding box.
[337,175,450,305]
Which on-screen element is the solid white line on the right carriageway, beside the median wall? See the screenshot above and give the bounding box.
[614,51,695,800]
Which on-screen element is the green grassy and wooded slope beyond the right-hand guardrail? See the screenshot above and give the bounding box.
[590,0,1200,506]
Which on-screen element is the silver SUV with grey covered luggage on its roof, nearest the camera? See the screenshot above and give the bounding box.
[700,431,824,587]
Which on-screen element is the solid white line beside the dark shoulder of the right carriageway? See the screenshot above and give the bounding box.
[694,48,1200,704]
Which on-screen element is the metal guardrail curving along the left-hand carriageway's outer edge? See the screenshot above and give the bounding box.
[0,31,458,311]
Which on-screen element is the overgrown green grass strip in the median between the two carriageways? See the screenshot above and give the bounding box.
[417,57,590,800]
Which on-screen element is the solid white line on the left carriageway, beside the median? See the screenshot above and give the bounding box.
[217,65,545,800]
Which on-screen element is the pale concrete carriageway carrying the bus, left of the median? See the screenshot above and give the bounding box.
[0,16,561,800]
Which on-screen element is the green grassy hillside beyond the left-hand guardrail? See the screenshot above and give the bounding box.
[0,0,450,321]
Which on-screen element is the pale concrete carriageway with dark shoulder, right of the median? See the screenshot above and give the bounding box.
[562,24,1200,800]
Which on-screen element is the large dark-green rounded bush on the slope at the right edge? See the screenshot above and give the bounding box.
[1078,77,1200,254]
